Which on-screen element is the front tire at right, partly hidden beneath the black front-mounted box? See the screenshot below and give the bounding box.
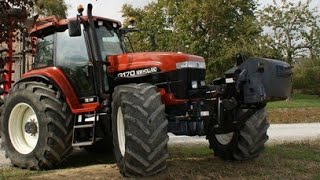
[207,108,270,161]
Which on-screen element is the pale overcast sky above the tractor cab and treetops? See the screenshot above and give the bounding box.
[66,0,320,21]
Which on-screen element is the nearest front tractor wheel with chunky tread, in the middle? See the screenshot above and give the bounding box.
[112,84,169,177]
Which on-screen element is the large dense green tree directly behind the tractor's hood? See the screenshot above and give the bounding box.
[122,0,265,80]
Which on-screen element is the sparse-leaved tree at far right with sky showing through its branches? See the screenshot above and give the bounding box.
[258,0,320,64]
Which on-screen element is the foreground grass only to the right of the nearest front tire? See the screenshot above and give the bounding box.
[159,142,320,179]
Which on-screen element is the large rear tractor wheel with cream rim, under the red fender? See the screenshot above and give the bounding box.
[0,81,73,170]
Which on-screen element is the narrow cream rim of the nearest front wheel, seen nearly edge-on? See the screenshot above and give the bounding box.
[117,107,126,156]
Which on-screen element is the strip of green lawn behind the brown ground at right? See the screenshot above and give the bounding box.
[267,94,320,110]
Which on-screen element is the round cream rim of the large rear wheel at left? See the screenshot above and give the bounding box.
[8,103,39,154]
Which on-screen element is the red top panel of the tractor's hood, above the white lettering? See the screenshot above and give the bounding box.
[108,52,205,73]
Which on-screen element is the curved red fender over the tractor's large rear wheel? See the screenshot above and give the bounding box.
[23,67,99,114]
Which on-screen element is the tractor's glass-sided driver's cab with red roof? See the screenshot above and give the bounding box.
[30,14,126,97]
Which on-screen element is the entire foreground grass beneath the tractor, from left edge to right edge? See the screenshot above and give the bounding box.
[0,141,320,179]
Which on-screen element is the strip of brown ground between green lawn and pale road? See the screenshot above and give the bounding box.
[268,108,320,124]
